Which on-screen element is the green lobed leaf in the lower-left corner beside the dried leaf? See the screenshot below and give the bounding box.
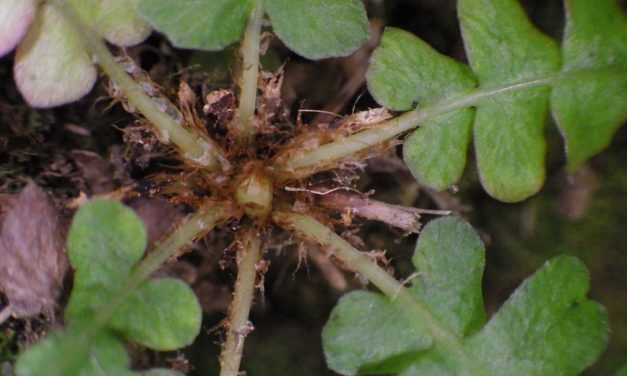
[17,200,202,376]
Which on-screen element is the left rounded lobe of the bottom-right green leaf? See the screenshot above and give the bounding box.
[322,291,432,375]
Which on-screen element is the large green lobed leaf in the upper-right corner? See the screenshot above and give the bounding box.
[368,0,627,202]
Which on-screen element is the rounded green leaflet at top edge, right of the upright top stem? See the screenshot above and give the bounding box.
[266,0,369,59]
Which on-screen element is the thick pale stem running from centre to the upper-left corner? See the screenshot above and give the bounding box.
[52,0,226,170]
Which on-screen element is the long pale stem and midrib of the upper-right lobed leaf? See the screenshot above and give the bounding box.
[274,68,624,179]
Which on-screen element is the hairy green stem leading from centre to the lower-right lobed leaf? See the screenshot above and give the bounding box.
[273,211,487,376]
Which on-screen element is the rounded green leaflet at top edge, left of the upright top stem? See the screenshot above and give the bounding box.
[139,0,254,50]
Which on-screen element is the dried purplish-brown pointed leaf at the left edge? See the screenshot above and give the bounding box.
[0,182,68,317]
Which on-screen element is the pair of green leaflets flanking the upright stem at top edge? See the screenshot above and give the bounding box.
[139,0,369,59]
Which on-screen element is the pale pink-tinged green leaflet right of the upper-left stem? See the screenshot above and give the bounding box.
[70,0,151,46]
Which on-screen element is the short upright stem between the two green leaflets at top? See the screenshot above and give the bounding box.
[237,0,263,139]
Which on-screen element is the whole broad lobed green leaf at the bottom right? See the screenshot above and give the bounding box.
[323,218,608,376]
